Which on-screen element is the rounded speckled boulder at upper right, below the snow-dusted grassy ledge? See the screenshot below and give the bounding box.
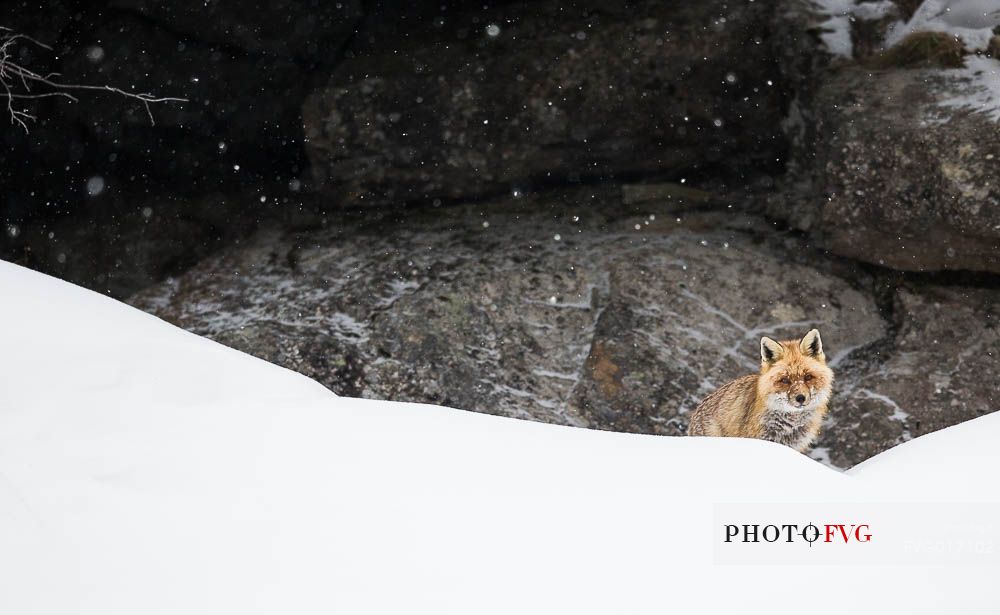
[772,63,1000,273]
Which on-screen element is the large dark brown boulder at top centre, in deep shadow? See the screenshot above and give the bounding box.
[303,1,789,204]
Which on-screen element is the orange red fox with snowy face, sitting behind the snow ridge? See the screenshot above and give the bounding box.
[688,329,833,453]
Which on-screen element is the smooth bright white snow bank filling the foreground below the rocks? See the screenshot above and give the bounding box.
[0,263,1000,615]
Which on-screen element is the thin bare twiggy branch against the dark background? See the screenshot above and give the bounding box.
[0,26,187,132]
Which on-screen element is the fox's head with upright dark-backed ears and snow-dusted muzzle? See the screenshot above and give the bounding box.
[757,329,833,412]
